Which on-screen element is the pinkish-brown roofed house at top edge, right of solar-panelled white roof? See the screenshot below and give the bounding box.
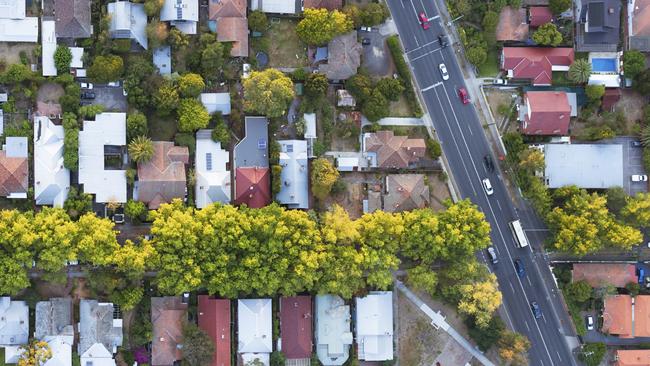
[208,0,248,57]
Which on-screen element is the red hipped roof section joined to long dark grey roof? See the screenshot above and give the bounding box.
[235,167,271,208]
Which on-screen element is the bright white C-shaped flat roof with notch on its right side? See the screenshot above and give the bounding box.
[79,113,126,203]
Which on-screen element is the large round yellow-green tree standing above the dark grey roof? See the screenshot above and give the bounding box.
[244,69,294,118]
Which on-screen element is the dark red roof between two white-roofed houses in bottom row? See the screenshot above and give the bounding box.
[280,296,313,360]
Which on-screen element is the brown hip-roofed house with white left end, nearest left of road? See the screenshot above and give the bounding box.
[362,131,426,169]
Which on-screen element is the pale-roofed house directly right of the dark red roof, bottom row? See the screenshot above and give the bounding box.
[315,295,352,366]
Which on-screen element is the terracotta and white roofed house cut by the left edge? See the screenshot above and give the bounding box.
[0,136,29,199]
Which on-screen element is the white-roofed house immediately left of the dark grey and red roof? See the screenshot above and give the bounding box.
[194,130,231,208]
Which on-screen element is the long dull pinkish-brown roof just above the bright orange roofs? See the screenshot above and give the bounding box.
[571,263,638,288]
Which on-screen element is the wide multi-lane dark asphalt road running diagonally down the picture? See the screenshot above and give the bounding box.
[380,0,576,366]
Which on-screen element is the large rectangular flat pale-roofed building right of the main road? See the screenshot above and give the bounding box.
[544,144,623,189]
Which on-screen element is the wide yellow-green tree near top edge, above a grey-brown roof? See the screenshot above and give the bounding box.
[296,8,352,46]
